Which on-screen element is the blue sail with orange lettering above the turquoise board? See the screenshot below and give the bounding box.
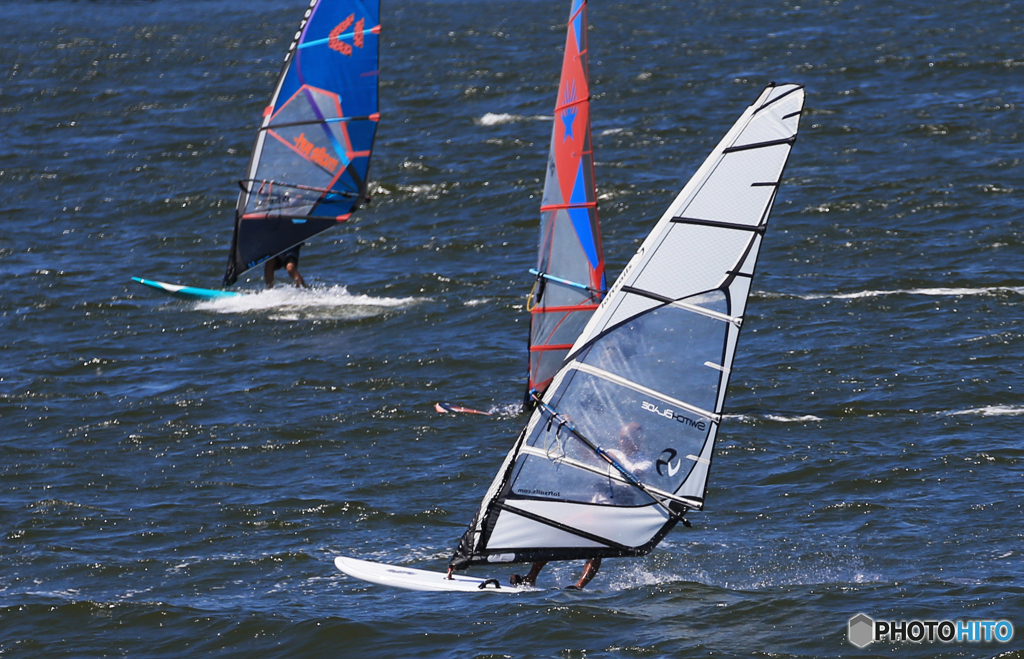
[224,0,380,285]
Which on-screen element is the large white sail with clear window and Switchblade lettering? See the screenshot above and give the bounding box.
[451,80,804,569]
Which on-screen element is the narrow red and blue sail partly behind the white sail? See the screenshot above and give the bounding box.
[526,0,606,404]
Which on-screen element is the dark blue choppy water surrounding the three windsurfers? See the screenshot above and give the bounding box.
[0,0,1024,659]
